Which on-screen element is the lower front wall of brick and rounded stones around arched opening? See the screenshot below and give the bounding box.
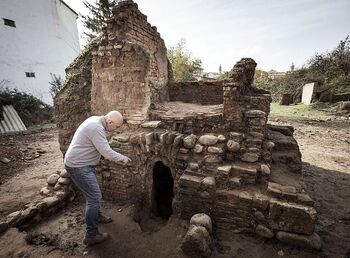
[100,122,316,241]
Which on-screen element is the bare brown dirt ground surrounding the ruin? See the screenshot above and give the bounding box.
[0,117,350,258]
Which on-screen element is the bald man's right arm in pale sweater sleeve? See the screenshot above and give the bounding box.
[91,130,128,162]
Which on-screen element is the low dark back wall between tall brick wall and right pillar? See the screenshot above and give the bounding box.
[169,81,223,105]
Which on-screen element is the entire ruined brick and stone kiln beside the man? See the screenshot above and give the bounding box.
[55,1,317,248]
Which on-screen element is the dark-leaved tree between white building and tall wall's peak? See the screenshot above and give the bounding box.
[80,0,121,39]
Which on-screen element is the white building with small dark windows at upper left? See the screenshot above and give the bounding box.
[0,0,80,104]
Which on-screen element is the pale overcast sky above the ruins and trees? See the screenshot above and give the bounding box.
[65,0,350,72]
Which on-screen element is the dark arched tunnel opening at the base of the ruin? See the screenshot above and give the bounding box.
[152,161,174,219]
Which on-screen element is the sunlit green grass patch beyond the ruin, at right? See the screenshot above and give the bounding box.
[269,103,334,121]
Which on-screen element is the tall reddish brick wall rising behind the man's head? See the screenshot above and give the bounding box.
[91,1,169,124]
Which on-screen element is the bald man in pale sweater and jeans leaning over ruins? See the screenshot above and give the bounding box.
[64,111,131,245]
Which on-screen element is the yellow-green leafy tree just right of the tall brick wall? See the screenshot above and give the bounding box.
[168,39,203,82]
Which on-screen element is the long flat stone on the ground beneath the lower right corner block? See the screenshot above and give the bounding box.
[276,231,322,250]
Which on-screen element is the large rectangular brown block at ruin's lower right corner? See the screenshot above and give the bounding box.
[268,200,316,235]
